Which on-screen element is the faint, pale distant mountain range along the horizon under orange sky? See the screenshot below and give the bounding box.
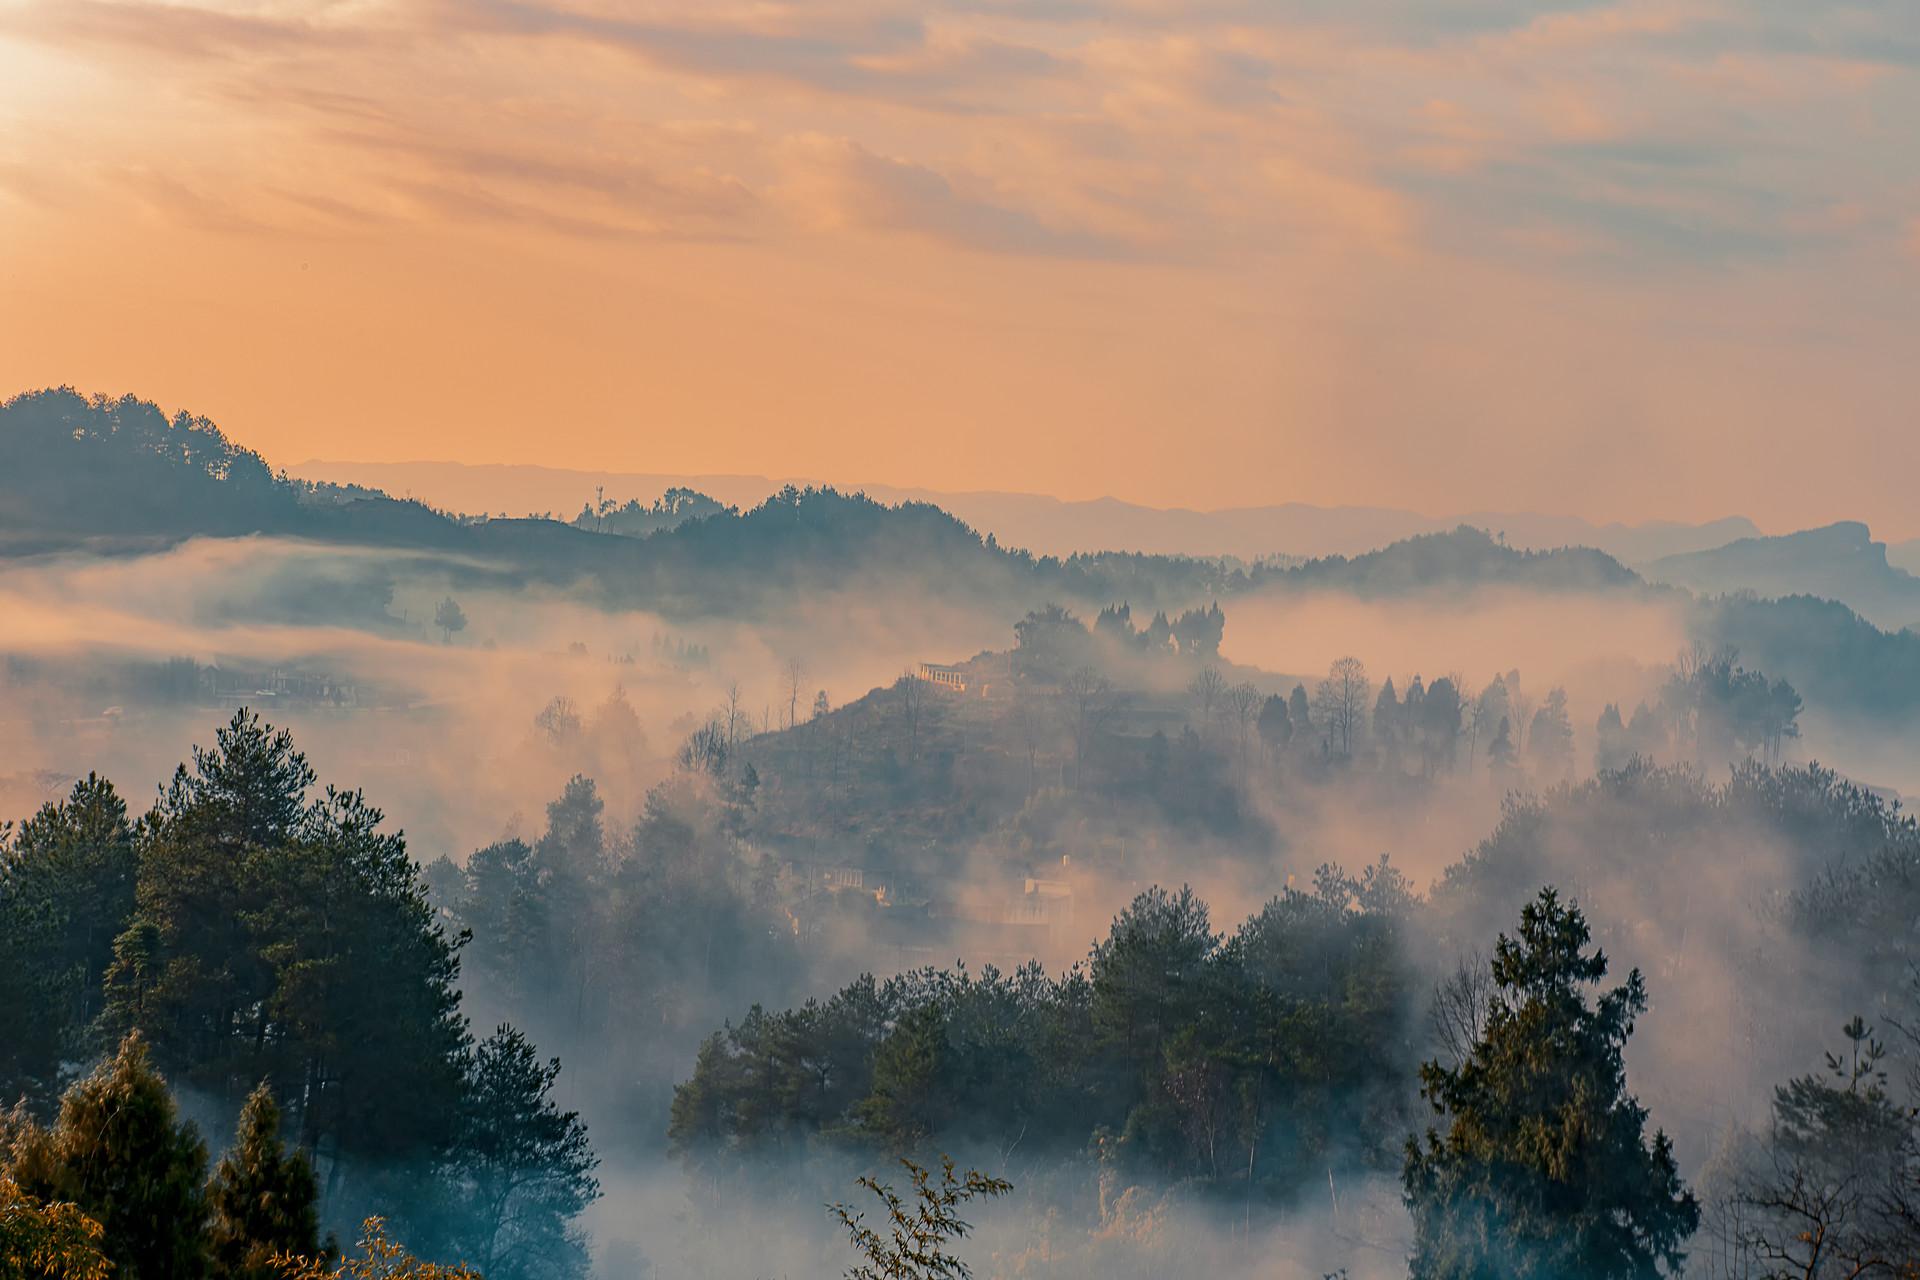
[290,461,1759,564]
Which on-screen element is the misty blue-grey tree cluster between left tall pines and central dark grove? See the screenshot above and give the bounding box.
[424,759,803,1144]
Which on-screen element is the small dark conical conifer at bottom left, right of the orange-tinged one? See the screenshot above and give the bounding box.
[207,1084,321,1280]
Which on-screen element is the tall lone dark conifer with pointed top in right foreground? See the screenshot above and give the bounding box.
[1402,889,1699,1280]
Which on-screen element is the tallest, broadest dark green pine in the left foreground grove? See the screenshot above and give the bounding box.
[106,712,467,1182]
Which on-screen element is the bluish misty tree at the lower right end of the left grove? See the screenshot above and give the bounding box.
[447,1027,599,1280]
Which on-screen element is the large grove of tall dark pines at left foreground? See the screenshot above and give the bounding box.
[0,710,595,1278]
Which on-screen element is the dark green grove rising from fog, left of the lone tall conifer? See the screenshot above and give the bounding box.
[668,860,1417,1196]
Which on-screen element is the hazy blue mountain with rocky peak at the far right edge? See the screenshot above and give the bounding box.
[1642,520,1920,631]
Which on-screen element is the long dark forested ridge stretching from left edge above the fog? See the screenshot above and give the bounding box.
[0,388,1640,614]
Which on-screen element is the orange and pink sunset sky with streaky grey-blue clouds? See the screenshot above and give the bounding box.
[0,0,1920,537]
